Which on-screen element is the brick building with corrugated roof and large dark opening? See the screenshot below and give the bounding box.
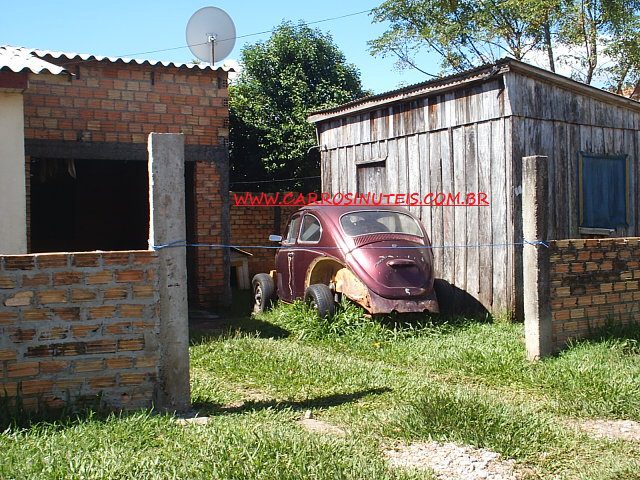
[0,46,229,307]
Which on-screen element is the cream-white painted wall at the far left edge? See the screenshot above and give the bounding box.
[0,91,27,254]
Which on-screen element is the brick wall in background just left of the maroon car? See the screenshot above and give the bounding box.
[230,197,299,277]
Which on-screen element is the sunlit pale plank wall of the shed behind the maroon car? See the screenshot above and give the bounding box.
[319,78,514,311]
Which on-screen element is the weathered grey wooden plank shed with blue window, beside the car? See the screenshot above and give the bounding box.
[309,59,640,317]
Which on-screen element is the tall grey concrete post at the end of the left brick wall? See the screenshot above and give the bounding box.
[148,133,190,412]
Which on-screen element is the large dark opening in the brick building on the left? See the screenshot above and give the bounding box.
[31,159,149,252]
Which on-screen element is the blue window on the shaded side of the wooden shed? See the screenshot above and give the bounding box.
[578,153,630,229]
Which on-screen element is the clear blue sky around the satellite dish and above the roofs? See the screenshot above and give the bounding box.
[0,0,438,93]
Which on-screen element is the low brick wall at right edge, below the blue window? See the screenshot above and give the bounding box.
[549,238,640,350]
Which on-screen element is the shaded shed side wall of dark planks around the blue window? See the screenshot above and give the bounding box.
[504,72,640,317]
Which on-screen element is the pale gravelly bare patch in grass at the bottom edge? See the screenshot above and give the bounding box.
[384,442,521,480]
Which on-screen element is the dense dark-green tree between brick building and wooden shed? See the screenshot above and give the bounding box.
[229,22,366,191]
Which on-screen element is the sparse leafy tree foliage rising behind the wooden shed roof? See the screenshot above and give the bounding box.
[370,0,640,88]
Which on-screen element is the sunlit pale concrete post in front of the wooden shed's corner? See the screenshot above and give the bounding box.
[522,156,553,360]
